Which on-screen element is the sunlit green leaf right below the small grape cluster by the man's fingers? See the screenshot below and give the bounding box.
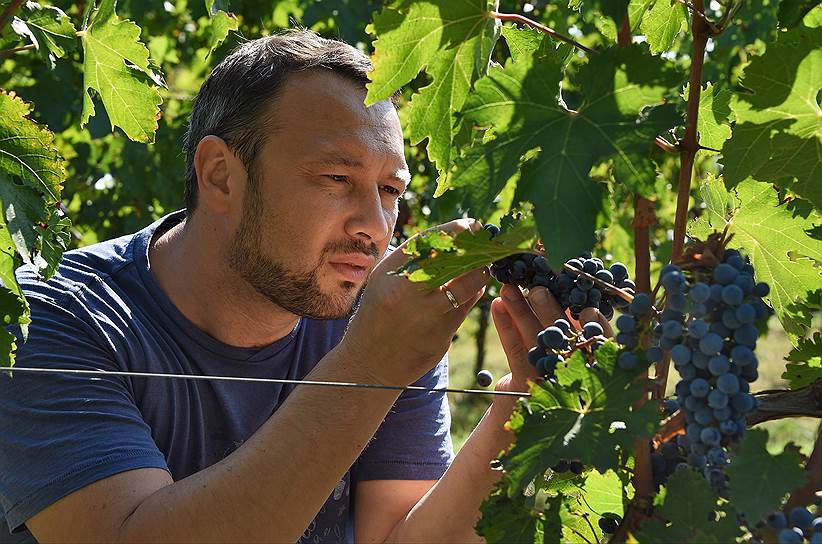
[501,342,659,496]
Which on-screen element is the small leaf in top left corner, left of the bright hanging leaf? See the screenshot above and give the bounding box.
[11,2,77,66]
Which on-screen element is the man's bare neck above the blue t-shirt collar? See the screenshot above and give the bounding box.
[149,214,299,347]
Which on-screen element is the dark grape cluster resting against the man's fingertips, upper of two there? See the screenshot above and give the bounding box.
[485,224,636,319]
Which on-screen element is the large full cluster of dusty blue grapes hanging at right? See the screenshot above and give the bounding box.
[664,250,769,493]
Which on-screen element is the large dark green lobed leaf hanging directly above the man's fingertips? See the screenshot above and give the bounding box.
[449,38,676,267]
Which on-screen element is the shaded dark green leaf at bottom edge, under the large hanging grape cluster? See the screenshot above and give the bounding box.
[634,470,741,544]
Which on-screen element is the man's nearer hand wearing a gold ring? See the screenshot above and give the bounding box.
[339,219,490,386]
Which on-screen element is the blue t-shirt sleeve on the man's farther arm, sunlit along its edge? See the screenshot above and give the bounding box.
[354,355,454,481]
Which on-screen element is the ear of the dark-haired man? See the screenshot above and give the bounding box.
[194,135,246,214]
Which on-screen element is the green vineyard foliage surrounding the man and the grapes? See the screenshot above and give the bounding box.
[0,0,822,543]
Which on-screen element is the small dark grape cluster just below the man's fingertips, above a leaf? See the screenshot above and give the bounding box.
[528,319,605,379]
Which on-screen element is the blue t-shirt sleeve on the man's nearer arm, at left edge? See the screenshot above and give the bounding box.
[0,296,168,531]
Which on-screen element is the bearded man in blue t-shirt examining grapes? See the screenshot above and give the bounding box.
[0,31,580,542]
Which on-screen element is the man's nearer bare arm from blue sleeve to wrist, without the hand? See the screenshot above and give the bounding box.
[27,346,404,542]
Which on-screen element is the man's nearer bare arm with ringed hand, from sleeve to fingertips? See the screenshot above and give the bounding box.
[27,219,488,542]
